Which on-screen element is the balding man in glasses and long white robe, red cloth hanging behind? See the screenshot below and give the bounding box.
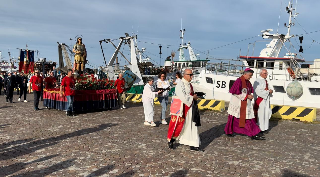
[167,69,200,151]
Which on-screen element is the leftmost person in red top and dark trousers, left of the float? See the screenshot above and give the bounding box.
[29,70,43,111]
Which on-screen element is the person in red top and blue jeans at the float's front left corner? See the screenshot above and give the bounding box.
[60,69,76,116]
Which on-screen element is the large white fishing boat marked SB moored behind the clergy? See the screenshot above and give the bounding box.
[193,2,320,108]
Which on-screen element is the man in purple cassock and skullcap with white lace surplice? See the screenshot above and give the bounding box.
[224,68,265,140]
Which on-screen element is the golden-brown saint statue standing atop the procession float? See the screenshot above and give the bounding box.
[72,37,87,74]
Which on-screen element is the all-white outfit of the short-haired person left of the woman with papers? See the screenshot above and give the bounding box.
[142,83,158,122]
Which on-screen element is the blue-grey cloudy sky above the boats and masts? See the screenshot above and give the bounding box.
[0,0,320,66]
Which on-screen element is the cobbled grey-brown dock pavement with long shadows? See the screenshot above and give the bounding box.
[0,95,320,177]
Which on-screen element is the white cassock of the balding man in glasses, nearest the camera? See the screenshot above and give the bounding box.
[175,79,200,147]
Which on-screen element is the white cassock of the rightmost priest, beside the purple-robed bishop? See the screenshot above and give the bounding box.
[253,77,272,131]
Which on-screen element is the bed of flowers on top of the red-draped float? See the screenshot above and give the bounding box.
[75,74,115,90]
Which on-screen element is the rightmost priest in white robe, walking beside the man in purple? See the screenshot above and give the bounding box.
[253,69,273,132]
